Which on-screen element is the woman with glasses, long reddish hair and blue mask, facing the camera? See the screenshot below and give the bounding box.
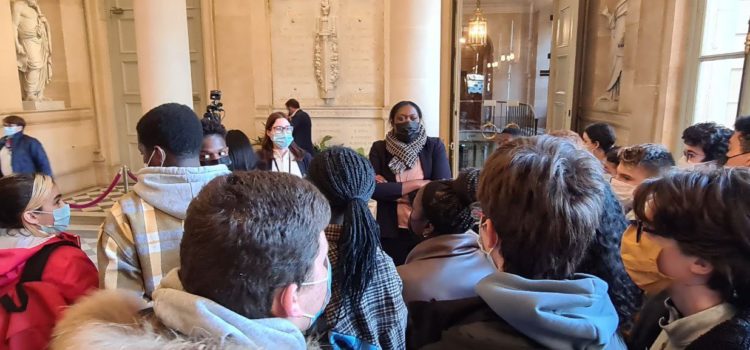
[258,112,312,177]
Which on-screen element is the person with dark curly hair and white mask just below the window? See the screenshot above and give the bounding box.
[677,123,733,169]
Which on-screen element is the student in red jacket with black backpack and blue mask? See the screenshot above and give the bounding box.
[0,174,99,350]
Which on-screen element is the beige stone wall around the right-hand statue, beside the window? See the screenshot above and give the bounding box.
[578,0,689,150]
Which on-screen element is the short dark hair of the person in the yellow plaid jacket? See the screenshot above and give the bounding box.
[136,103,203,159]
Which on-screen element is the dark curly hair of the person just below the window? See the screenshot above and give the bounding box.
[682,122,734,164]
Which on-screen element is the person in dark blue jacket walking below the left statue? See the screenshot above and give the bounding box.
[0,115,52,177]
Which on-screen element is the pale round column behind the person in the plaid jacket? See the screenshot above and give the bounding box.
[133,0,193,112]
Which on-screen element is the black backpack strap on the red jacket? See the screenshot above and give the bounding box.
[0,241,76,313]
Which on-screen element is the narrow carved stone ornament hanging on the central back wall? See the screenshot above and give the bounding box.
[313,0,339,104]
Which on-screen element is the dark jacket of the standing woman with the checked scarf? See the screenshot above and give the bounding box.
[370,137,452,238]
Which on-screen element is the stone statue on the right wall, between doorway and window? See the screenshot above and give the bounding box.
[600,0,628,101]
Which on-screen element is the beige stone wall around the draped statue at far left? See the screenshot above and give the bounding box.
[0,0,100,193]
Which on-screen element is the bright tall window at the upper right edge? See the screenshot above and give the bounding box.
[692,0,750,128]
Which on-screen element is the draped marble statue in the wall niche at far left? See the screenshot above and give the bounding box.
[12,0,52,101]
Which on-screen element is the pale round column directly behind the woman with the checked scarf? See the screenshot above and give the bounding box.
[386,0,441,137]
